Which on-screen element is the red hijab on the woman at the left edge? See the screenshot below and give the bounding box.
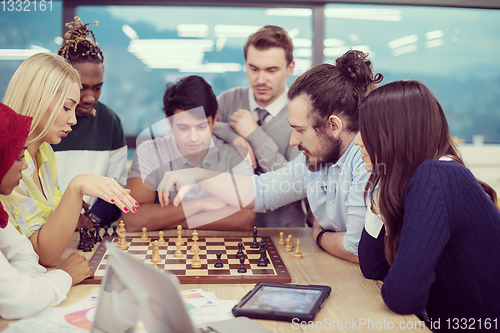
[0,103,32,228]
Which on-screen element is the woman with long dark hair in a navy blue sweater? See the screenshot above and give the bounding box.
[355,81,500,330]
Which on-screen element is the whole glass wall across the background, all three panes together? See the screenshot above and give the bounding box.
[0,0,500,143]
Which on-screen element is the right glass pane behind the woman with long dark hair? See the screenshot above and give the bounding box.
[324,4,500,143]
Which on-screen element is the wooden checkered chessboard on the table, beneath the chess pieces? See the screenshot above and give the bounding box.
[81,235,292,284]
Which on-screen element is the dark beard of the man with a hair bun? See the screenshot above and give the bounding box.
[298,135,342,172]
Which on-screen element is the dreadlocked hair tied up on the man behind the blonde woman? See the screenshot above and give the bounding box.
[57,16,104,63]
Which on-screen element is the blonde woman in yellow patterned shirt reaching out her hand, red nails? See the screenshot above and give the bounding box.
[0,53,138,266]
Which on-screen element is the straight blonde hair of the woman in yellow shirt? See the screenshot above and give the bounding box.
[3,53,81,143]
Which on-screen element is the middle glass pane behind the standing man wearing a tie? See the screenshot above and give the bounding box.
[77,6,312,139]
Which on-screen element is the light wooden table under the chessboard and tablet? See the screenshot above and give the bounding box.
[0,228,430,332]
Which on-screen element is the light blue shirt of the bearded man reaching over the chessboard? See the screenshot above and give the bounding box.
[252,137,370,255]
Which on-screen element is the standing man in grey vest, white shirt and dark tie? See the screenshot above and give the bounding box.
[214,26,305,227]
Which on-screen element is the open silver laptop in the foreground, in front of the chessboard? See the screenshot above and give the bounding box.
[91,242,272,333]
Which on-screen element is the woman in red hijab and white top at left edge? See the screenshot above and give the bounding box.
[0,103,93,319]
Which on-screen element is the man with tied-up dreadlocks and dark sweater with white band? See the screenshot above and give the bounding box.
[52,17,127,229]
